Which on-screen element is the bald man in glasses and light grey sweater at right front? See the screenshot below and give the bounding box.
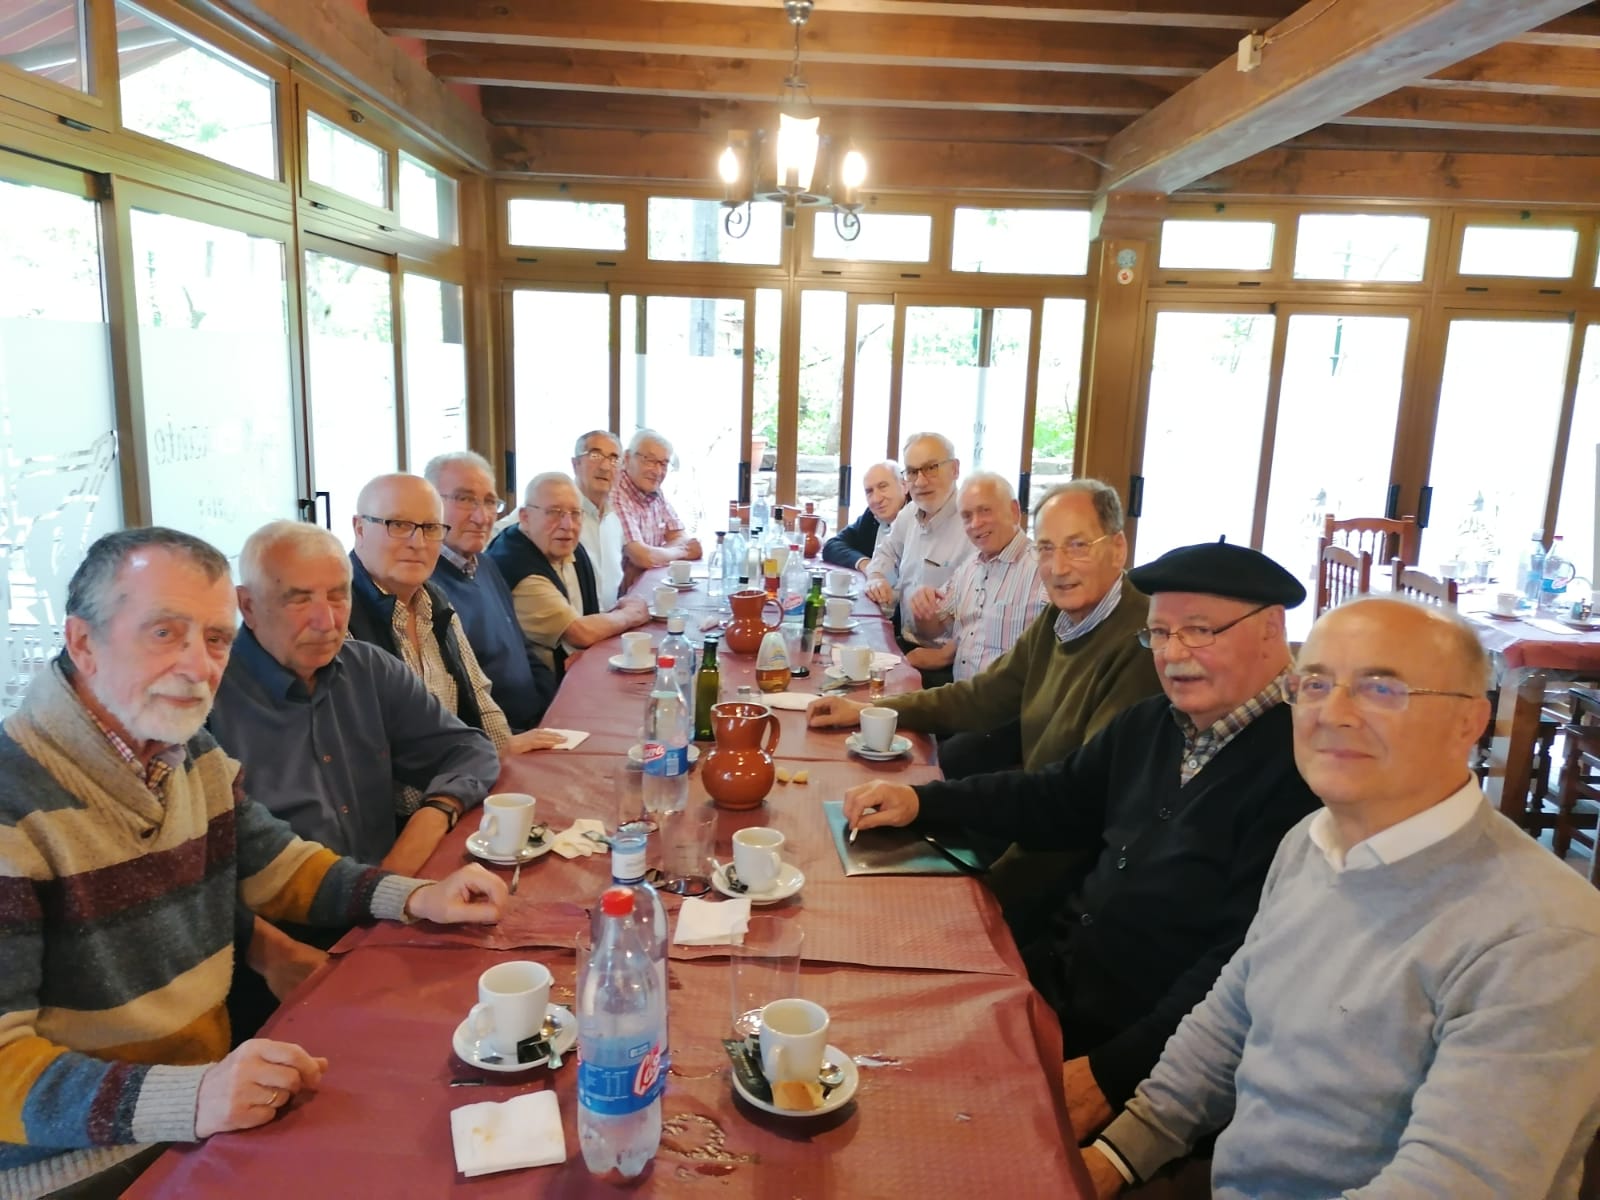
[1085,598,1600,1200]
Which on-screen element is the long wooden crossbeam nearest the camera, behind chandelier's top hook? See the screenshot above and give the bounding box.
[368,0,1238,77]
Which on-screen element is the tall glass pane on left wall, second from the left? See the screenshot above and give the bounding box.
[131,210,298,558]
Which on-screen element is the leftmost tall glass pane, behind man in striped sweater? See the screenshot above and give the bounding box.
[0,179,122,715]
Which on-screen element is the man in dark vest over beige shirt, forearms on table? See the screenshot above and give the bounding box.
[488,470,650,675]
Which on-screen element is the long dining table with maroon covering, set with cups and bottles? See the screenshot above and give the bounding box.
[128,566,1093,1200]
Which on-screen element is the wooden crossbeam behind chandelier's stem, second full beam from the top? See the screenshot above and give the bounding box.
[427,43,1179,117]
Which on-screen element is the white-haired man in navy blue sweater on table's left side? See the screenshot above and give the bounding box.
[422,450,557,732]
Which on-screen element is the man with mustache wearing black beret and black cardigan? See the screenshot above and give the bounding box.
[845,542,1318,1139]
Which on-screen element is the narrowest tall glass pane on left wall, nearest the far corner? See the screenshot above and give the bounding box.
[400,275,467,474]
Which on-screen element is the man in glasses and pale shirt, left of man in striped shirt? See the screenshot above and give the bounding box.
[867,434,974,650]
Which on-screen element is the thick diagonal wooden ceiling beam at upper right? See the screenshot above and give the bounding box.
[1106,0,1581,192]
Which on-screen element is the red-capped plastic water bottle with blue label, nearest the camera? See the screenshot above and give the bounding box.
[578,888,667,1179]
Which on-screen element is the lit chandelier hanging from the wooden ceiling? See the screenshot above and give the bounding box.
[717,0,867,242]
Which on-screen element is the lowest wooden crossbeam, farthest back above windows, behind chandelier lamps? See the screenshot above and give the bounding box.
[496,128,1099,197]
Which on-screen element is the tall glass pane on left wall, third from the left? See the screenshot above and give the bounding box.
[306,250,400,546]
